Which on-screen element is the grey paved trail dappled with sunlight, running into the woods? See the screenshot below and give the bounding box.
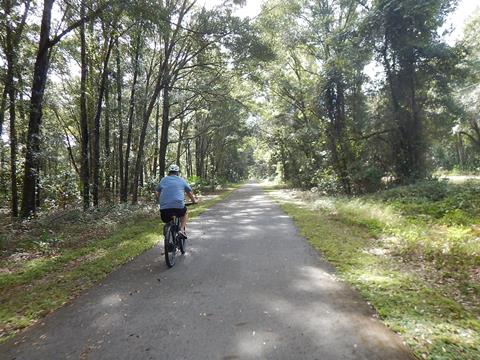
[0,185,413,360]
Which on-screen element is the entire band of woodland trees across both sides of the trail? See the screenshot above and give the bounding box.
[0,0,480,217]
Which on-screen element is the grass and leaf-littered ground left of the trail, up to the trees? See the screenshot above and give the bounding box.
[0,187,236,343]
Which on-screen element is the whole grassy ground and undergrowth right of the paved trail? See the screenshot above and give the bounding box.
[270,181,480,359]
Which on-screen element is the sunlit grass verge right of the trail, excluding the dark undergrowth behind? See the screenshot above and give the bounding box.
[270,190,480,360]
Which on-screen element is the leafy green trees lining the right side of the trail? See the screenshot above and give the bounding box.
[251,0,478,194]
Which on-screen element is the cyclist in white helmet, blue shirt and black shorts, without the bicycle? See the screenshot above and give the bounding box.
[155,164,197,239]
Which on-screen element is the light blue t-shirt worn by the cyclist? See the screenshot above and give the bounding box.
[156,175,192,210]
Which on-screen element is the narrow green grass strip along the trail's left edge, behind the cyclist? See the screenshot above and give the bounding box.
[0,187,236,342]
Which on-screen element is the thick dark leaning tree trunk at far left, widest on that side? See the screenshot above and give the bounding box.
[22,0,54,218]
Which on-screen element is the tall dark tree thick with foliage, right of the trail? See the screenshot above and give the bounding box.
[369,0,453,183]
